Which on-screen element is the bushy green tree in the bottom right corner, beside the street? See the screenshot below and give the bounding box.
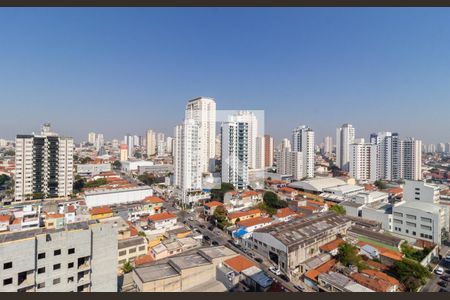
[391,258,431,291]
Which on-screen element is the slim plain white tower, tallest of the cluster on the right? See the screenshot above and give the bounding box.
[336,124,355,171]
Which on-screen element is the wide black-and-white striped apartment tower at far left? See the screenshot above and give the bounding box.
[14,124,74,201]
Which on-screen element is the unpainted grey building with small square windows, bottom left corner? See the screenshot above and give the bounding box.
[0,221,117,292]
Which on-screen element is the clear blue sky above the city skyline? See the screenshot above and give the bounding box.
[0,8,450,143]
